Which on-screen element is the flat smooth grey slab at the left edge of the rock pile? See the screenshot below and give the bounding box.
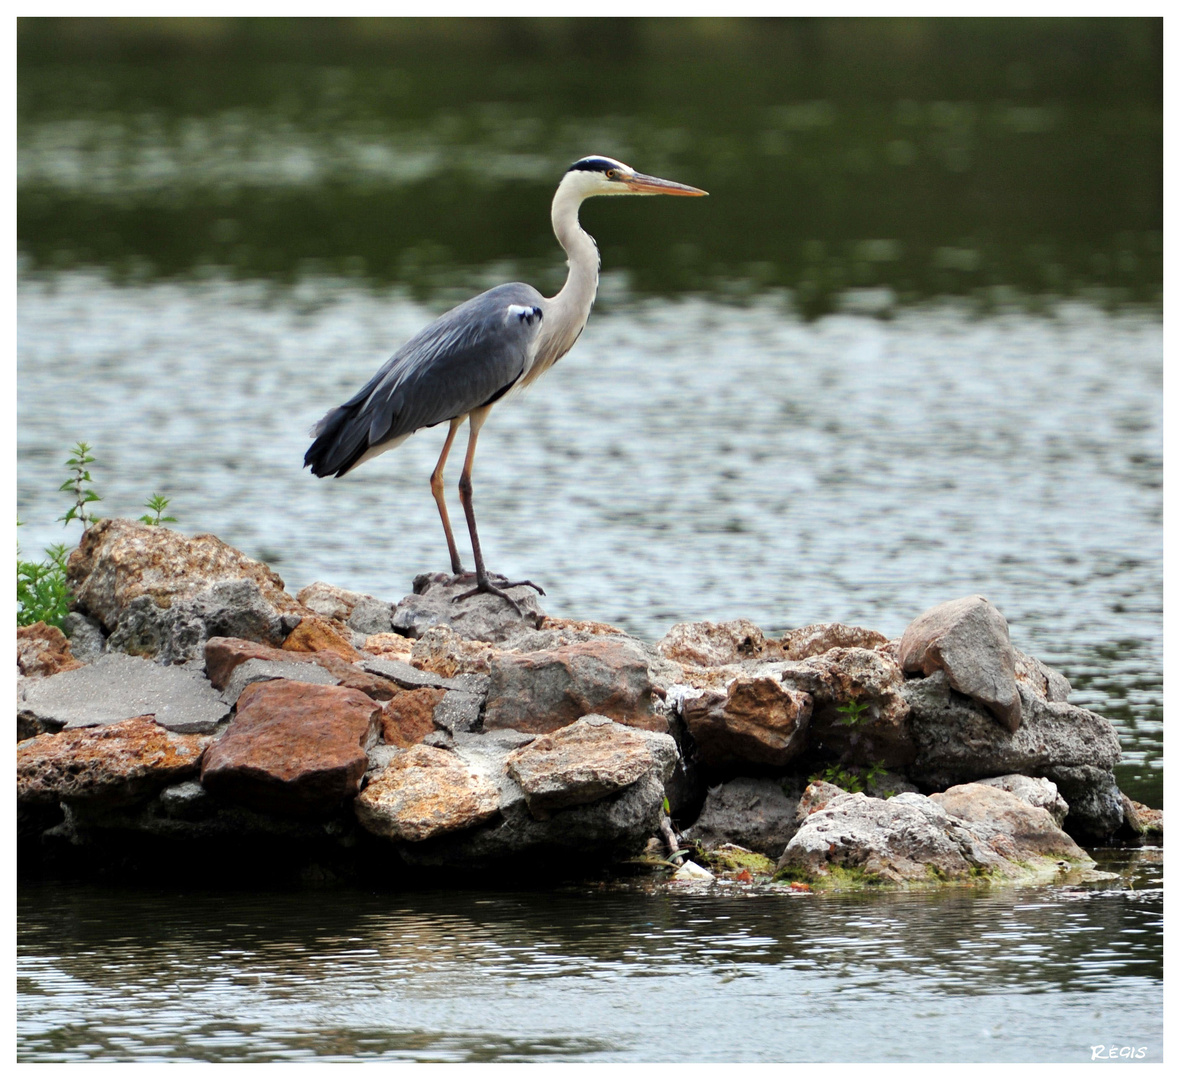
[18,653,229,734]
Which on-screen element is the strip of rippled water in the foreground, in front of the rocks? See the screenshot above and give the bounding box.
[18,851,1162,1061]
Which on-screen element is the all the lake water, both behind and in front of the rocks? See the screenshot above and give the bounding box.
[17,19,1163,1061]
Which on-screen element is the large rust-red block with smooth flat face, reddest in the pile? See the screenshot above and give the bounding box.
[201,680,381,817]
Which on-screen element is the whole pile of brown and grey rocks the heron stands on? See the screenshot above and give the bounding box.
[17,519,1162,890]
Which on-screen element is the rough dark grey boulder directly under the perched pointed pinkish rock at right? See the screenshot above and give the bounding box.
[902,672,1120,788]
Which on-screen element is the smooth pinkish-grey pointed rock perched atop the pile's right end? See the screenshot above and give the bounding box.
[898,596,1021,732]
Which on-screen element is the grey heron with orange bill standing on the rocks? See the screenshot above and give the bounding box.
[303,156,708,607]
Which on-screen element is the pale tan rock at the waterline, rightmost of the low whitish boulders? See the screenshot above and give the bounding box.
[930,784,1088,862]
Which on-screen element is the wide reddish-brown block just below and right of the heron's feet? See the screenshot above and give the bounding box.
[484,637,668,734]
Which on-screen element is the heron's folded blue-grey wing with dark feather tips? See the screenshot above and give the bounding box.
[303,282,544,476]
